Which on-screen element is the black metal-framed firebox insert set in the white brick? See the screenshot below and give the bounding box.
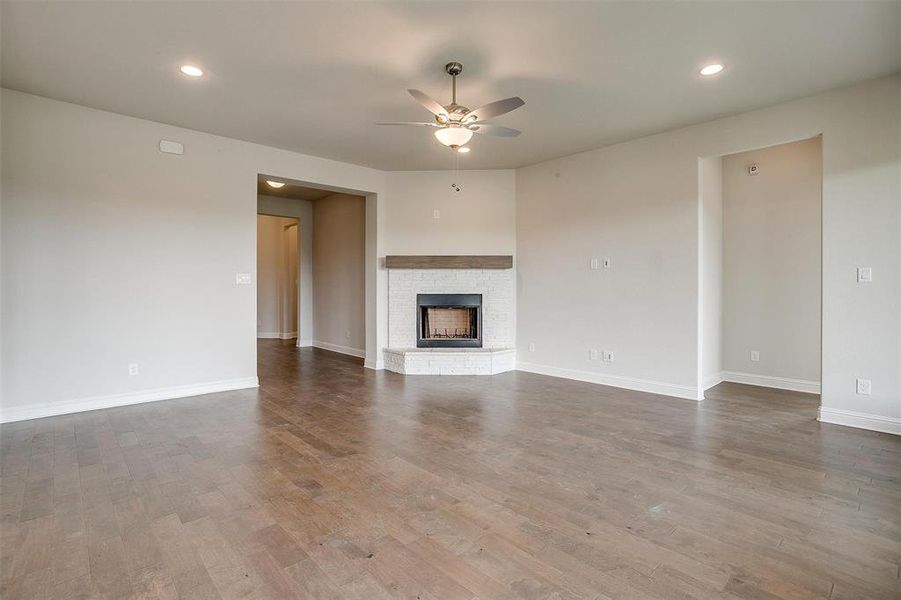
[416,294,482,348]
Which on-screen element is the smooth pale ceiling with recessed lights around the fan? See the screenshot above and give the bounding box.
[0,0,901,170]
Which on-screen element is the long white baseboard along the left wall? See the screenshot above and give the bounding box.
[0,377,260,423]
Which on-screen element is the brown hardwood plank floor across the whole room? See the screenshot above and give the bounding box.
[0,340,901,600]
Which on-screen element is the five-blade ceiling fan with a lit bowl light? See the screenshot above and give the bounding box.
[376,61,525,150]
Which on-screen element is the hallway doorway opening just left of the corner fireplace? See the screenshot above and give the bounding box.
[257,175,367,366]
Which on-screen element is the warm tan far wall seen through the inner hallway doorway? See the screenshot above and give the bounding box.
[257,215,298,339]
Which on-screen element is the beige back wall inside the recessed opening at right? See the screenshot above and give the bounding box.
[723,138,823,383]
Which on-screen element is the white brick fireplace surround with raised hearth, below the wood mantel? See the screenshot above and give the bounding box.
[385,268,515,375]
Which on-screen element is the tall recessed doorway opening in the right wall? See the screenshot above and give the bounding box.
[698,136,823,402]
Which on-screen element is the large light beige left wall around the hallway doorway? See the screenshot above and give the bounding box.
[0,90,385,420]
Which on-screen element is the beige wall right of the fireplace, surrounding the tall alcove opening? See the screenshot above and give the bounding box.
[516,76,901,432]
